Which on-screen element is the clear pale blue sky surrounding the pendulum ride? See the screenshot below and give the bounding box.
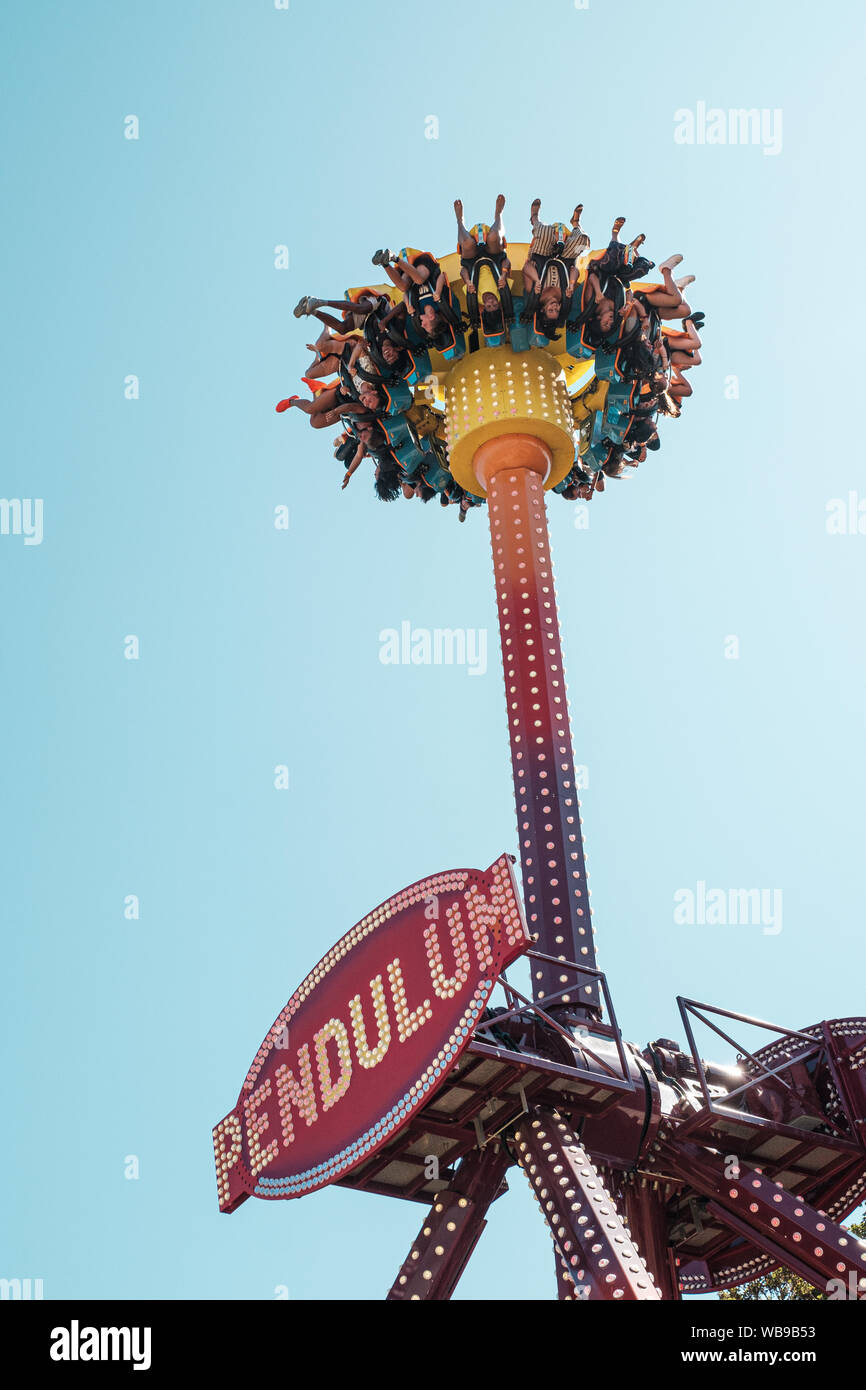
[0,0,866,1298]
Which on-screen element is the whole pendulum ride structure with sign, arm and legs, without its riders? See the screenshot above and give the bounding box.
[214,201,866,1300]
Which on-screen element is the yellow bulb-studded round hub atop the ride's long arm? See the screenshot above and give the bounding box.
[445,348,574,496]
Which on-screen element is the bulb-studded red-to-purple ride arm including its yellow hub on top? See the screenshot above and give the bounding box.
[445,348,602,1020]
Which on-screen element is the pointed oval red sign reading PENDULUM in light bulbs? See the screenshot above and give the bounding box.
[214,855,532,1212]
